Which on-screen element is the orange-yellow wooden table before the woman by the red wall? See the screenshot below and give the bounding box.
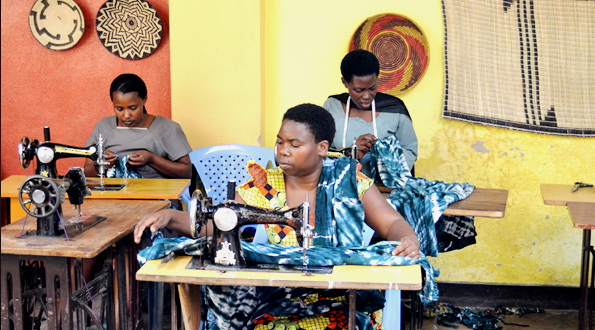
[1,175,190,222]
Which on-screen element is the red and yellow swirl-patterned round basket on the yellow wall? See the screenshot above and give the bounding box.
[349,14,430,95]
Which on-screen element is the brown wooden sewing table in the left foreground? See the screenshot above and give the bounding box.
[1,199,170,329]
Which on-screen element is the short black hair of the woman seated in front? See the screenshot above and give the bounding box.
[283,103,335,144]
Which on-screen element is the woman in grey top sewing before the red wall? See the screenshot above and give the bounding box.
[85,74,192,179]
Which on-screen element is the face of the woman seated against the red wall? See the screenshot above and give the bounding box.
[112,92,147,127]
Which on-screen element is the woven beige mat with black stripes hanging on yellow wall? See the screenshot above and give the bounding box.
[442,0,595,137]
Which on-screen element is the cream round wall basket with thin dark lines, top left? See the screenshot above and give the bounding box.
[29,0,85,50]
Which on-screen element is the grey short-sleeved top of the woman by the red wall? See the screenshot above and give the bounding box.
[86,116,192,179]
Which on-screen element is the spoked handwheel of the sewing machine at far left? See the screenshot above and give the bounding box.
[19,175,64,218]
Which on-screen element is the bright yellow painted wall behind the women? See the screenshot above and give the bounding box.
[170,0,595,286]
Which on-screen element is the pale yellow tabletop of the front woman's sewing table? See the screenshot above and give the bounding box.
[136,256,422,290]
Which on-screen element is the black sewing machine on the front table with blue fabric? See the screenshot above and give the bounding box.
[187,183,332,274]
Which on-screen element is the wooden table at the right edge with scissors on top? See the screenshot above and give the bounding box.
[541,184,595,330]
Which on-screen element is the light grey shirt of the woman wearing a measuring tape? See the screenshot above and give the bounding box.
[324,97,417,177]
